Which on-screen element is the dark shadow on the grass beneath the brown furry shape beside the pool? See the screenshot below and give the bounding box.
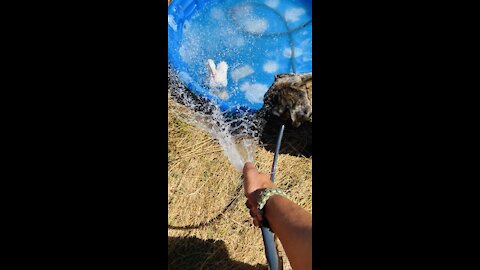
[260,115,312,158]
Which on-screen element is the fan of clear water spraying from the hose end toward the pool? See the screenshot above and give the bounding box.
[168,66,263,172]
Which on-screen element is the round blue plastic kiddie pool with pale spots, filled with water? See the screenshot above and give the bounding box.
[168,0,312,112]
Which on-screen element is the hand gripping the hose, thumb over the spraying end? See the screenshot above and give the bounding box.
[243,162,275,226]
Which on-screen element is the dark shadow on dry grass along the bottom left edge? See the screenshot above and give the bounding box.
[168,237,268,270]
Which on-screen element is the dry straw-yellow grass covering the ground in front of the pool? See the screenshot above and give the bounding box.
[168,99,312,270]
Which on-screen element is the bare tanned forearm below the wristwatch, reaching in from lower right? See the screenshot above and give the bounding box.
[264,195,312,270]
